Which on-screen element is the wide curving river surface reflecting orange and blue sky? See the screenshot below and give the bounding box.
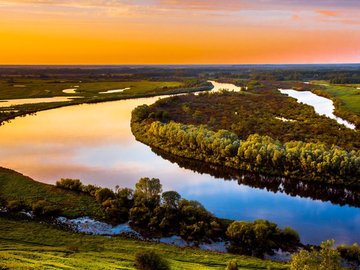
[0,90,360,243]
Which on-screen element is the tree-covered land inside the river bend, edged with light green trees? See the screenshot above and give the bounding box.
[131,82,360,186]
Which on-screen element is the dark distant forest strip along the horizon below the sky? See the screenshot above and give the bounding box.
[0,64,360,84]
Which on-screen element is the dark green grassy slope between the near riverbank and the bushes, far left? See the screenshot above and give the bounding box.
[0,168,105,219]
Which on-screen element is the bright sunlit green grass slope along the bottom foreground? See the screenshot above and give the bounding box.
[0,217,288,269]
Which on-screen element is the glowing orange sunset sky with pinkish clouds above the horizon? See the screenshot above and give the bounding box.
[0,0,360,64]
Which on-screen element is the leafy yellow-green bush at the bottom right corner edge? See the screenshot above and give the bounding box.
[290,240,342,270]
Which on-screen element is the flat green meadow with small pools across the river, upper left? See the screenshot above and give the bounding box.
[0,79,211,124]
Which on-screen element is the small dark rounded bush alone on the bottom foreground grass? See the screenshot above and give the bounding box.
[135,250,170,270]
